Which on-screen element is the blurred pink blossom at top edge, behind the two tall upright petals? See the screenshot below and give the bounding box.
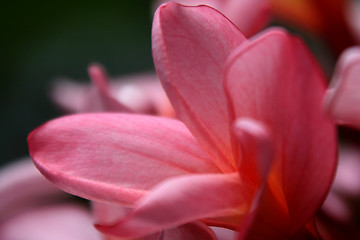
[155,0,271,37]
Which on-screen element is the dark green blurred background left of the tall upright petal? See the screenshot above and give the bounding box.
[0,0,153,166]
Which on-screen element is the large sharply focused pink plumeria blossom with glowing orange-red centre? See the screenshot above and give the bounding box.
[28,3,336,239]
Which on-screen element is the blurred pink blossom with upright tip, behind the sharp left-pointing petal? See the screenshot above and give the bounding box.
[51,63,174,117]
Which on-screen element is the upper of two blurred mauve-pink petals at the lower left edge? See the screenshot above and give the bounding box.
[0,158,70,222]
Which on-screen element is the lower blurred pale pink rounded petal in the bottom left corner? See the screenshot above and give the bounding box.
[0,205,102,240]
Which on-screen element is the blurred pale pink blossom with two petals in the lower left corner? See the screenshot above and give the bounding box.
[0,159,101,240]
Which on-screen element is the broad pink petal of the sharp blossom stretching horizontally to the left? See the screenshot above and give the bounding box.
[28,114,219,204]
